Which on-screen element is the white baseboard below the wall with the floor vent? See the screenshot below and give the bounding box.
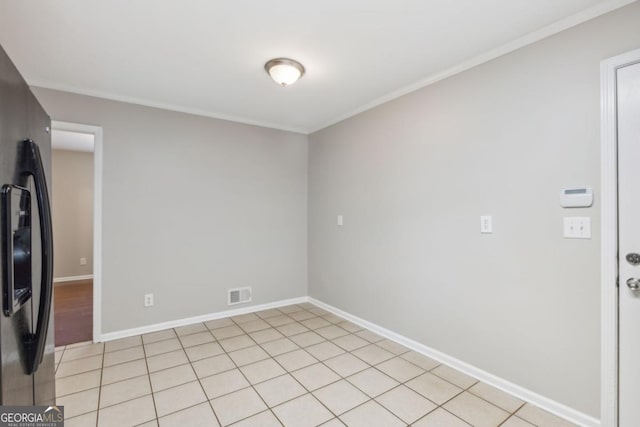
[100,297,309,342]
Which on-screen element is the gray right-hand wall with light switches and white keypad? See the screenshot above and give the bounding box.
[309,3,640,418]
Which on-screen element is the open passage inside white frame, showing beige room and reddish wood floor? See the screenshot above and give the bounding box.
[51,129,95,346]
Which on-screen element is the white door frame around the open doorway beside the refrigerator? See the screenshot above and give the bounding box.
[51,120,102,342]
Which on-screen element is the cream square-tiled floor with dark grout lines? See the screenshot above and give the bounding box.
[56,304,572,427]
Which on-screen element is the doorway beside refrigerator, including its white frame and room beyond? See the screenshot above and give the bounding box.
[51,121,102,346]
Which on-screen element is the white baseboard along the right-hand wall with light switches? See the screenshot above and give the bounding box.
[309,297,600,427]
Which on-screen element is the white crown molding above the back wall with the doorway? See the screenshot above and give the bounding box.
[27,79,308,135]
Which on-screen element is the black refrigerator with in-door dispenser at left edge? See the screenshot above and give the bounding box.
[0,46,55,405]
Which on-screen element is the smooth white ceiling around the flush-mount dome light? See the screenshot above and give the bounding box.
[0,0,633,133]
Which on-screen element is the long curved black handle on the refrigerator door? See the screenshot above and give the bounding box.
[22,139,53,374]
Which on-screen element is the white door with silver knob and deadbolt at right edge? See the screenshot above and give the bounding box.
[617,63,640,427]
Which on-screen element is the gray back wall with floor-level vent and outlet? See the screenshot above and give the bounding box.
[33,88,307,332]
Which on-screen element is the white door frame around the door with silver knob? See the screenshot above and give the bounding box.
[600,49,640,427]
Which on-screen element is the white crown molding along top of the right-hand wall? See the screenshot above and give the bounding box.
[308,0,637,134]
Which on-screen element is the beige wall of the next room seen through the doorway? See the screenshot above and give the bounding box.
[51,150,93,278]
